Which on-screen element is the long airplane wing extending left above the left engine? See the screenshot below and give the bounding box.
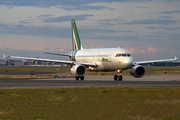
[4,55,97,67]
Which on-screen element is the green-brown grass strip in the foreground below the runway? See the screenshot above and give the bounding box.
[0,86,180,120]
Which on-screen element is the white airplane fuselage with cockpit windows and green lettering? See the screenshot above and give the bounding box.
[74,48,133,71]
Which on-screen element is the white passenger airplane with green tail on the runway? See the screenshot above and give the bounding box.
[4,20,177,81]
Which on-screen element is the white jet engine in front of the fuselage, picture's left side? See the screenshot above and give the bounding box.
[70,65,86,77]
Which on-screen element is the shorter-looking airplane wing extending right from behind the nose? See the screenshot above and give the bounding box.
[133,57,177,65]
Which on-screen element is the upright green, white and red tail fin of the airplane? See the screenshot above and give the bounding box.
[71,20,82,51]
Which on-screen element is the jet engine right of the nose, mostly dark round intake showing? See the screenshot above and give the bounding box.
[130,65,145,78]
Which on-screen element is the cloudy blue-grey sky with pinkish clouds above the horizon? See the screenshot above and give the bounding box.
[0,0,180,61]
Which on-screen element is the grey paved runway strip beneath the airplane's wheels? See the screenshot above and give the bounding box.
[0,75,180,88]
